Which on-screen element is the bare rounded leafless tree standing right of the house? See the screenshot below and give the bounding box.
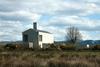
[66,26,82,45]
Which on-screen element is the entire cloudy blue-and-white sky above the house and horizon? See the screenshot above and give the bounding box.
[0,0,100,41]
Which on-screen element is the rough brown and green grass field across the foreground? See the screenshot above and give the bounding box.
[0,50,100,67]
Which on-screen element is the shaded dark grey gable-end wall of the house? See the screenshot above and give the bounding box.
[23,30,39,48]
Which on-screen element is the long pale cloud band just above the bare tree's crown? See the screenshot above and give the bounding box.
[44,16,100,31]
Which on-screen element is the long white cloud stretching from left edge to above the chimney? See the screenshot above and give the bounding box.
[0,11,40,22]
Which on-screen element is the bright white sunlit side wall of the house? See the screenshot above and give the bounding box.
[39,32,54,48]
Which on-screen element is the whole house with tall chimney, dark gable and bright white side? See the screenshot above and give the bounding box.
[22,22,54,49]
